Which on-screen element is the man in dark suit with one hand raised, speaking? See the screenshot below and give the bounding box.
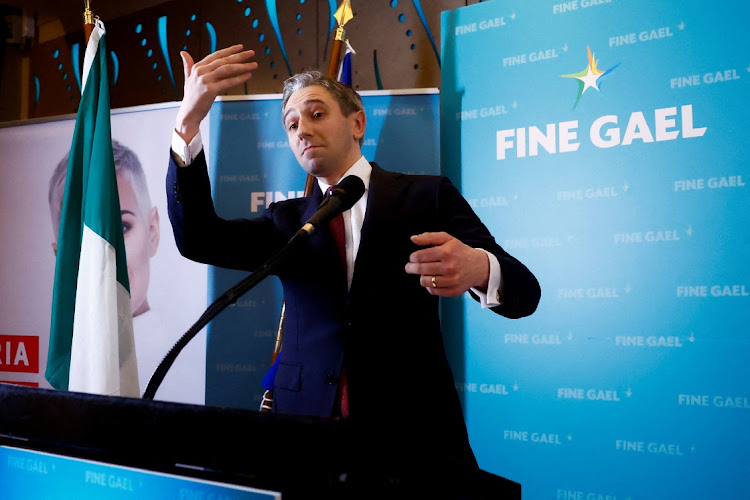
[167,46,540,494]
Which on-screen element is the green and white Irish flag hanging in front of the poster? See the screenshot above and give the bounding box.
[46,21,140,397]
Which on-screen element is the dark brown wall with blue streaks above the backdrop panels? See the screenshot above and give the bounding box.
[0,0,488,121]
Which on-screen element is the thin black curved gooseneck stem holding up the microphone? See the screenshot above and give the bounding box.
[143,229,314,400]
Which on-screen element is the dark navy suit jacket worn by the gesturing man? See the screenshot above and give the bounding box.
[167,153,540,465]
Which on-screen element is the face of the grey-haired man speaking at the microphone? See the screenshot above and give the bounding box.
[284,85,365,184]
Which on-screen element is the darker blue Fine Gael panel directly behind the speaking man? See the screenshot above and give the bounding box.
[206,92,440,409]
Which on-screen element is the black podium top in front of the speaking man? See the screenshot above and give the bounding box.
[0,384,521,500]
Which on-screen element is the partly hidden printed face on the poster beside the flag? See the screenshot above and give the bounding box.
[117,174,159,316]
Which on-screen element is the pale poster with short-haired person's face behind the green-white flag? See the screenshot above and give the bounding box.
[0,104,207,404]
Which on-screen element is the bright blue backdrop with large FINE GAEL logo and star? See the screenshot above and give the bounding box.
[441,0,750,500]
